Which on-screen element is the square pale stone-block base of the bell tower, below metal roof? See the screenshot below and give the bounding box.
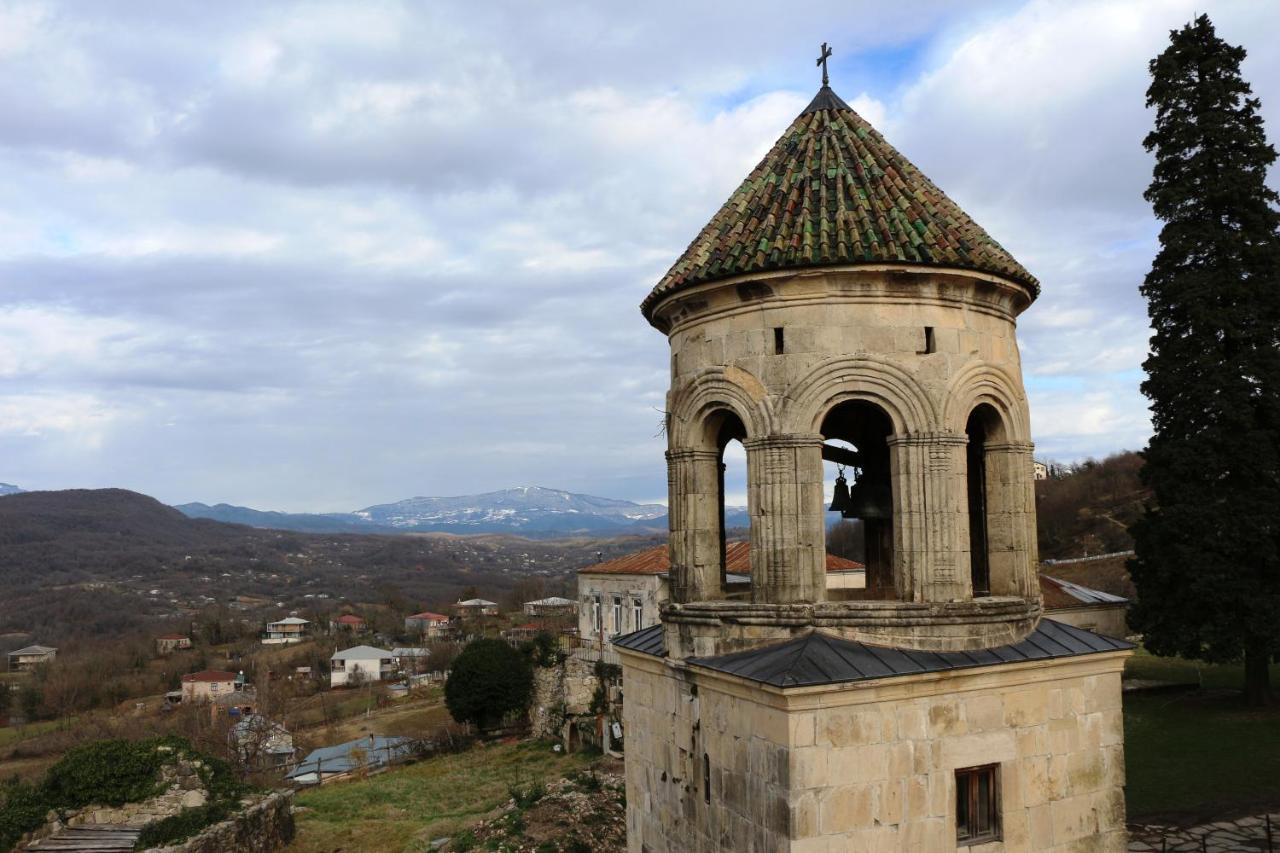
[625,654,1125,853]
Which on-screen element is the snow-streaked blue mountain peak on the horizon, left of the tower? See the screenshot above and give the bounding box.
[355,485,667,533]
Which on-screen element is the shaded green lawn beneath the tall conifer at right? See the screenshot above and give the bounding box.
[1124,649,1280,824]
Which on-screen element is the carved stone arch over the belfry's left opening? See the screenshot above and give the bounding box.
[669,368,773,448]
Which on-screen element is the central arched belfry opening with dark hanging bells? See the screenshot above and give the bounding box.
[822,400,897,599]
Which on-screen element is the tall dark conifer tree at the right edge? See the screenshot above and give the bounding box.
[1130,15,1280,704]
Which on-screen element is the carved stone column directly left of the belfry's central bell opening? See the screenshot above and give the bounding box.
[744,435,827,605]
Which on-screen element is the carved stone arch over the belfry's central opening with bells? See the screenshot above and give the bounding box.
[782,356,938,435]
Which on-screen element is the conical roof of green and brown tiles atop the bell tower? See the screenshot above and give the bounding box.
[641,86,1039,316]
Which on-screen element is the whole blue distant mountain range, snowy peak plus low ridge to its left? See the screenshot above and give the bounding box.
[177,485,721,538]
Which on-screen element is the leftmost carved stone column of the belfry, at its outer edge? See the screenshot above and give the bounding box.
[667,450,721,603]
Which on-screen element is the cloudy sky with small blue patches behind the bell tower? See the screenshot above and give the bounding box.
[0,0,1280,511]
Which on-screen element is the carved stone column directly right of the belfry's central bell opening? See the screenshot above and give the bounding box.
[888,432,972,602]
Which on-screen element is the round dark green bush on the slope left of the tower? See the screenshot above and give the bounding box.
[444,639,534,729]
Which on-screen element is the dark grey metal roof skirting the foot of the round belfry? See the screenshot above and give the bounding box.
[686,619,1134,688]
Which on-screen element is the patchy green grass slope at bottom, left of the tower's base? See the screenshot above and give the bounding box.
[288,742,588,853]
